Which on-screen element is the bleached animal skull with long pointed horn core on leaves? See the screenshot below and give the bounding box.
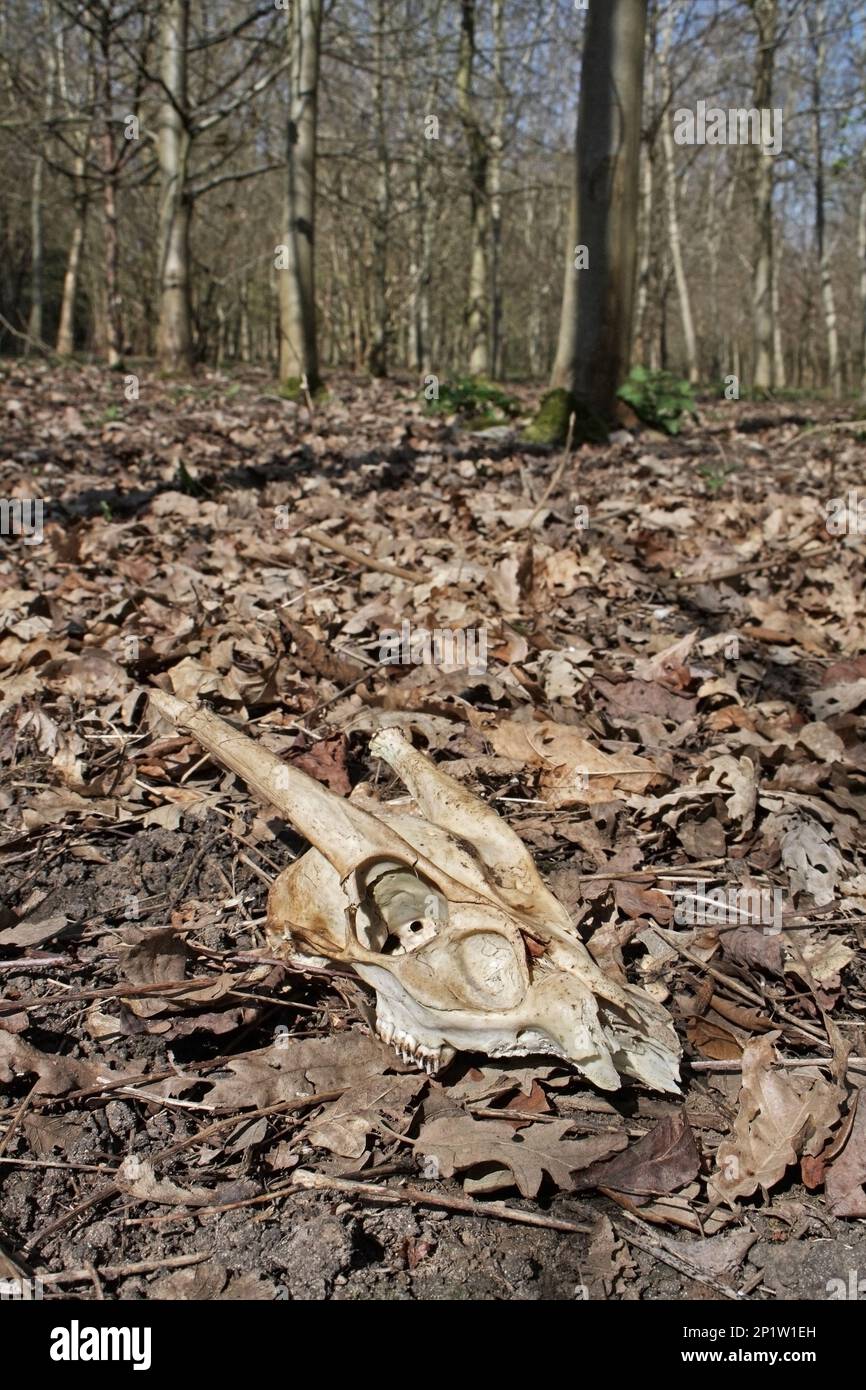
[150,691,680,1091]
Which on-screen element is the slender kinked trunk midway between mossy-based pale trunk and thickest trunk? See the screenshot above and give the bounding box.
[457,0,491,377]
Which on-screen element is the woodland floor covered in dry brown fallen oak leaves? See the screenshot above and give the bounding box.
[0,363,866,1300]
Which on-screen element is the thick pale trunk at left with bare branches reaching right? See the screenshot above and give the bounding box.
[157,0,193,373]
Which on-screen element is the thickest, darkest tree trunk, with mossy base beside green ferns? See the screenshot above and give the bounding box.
[553,0,646,418]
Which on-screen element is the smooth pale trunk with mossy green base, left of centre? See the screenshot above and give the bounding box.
[279,0,321,391]
